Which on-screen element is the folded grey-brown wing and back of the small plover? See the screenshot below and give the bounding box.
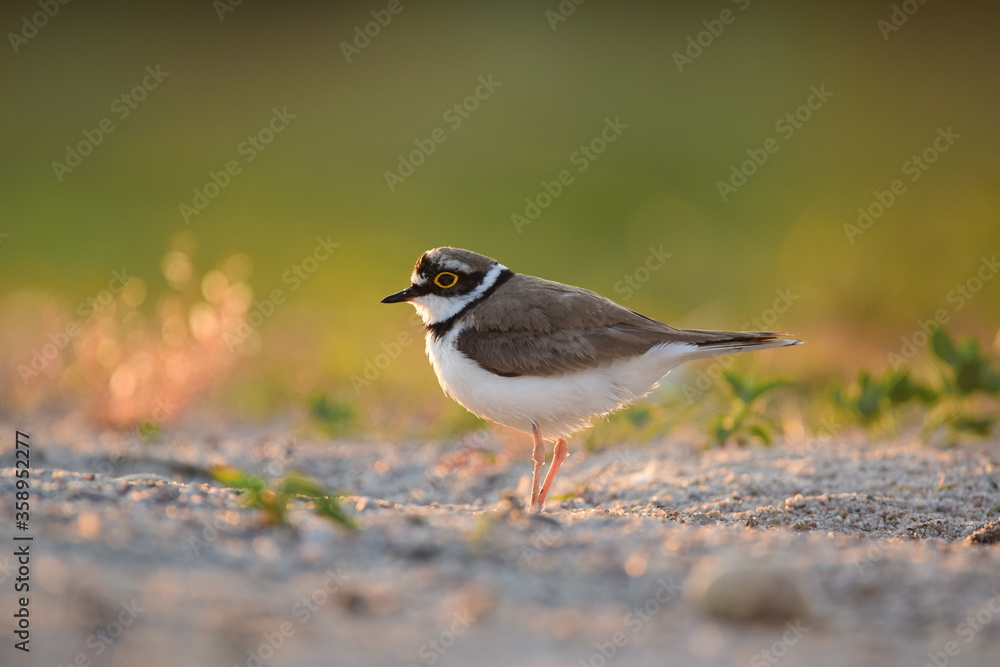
[457,274,788,377]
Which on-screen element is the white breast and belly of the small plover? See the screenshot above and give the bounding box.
[427,325,696,438]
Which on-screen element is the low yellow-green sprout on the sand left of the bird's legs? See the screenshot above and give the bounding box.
[212,466,360,532]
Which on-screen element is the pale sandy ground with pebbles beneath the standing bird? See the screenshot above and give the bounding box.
[0,418,1000,667]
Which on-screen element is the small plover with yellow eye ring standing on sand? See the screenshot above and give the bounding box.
[381,246,803,514]
